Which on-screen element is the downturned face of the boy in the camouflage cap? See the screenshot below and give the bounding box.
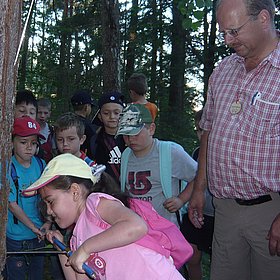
[123,123,155,156]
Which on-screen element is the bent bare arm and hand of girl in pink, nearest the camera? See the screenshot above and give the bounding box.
[67,198,148,272]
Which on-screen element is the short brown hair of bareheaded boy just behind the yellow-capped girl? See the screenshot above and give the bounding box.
[54,112,85,138]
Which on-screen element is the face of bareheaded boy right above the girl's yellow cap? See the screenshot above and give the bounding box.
[55,126,86,157]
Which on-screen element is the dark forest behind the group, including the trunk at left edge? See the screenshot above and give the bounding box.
[0,0,280,279]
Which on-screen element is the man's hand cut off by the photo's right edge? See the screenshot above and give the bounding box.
[266,214,280,257]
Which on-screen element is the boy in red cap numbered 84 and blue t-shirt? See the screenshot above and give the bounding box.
[4,116,50,280]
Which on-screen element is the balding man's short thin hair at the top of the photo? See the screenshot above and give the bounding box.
[216,0,276,23]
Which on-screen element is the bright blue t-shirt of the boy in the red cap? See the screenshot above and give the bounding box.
[7,156,46,240]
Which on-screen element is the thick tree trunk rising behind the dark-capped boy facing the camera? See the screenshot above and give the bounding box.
[101,0,121,92]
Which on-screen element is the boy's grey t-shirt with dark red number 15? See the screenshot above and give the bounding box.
[122,138,197,225]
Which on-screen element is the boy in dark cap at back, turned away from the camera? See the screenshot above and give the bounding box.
[71,90,97,158]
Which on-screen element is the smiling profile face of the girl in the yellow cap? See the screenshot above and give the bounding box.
[39,184,77,228]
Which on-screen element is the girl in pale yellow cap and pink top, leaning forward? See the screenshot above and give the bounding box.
[24,154,184,280]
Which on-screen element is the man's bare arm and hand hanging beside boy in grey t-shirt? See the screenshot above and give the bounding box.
[188,130,209,228]
